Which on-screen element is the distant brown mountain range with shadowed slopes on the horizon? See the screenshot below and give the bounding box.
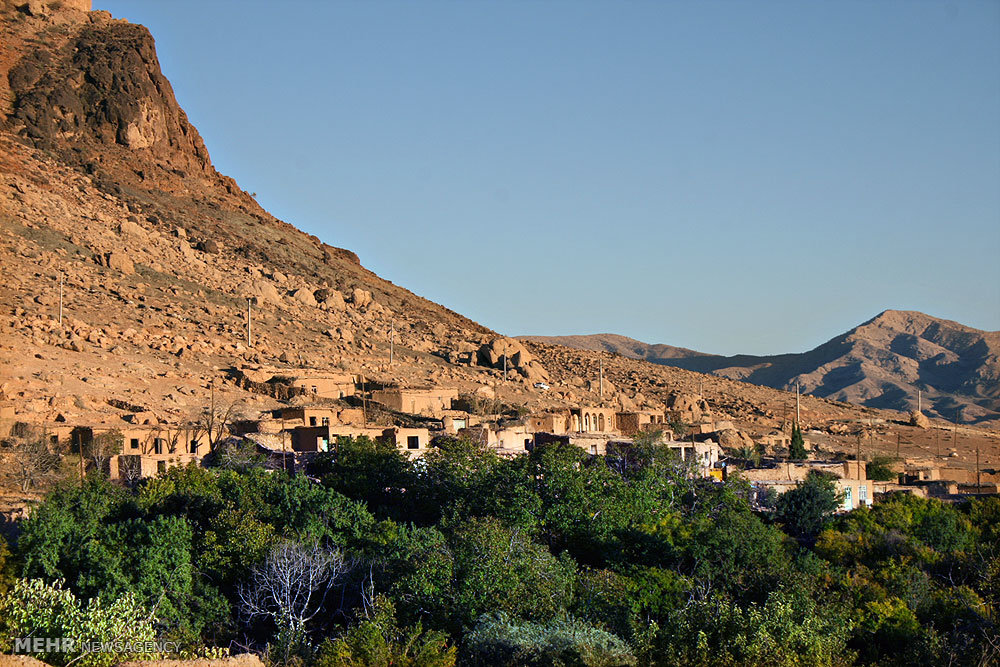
[522,310,1000,425]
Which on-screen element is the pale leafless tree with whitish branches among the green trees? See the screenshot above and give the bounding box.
[239,542,350,661]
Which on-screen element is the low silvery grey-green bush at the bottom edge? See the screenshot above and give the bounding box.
[465,613,636,667]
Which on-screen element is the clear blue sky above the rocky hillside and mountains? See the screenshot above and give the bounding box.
[95,0,1000,354]
